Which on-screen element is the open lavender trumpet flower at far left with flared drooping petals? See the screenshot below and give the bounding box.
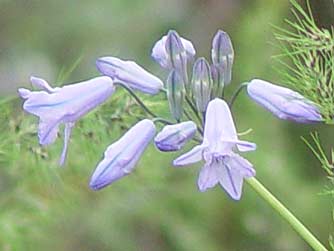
[18,77,115,165]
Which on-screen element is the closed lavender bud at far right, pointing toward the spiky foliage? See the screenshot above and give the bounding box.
[247,79,323,123]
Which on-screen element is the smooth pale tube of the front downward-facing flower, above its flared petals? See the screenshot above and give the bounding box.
[204,98,238,144]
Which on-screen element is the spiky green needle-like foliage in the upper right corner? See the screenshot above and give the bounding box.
[276,0,334,124]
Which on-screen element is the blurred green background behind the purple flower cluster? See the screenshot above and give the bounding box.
[0,0,334,251]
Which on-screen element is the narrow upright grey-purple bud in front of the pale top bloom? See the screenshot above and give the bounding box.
[165,30,188,83]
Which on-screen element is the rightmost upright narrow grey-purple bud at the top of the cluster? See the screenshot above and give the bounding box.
[211,30,234,85]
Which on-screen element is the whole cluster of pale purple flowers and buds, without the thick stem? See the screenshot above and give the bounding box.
[18,30,322,200]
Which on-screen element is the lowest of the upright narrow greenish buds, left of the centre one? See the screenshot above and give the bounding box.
[167,70,185,121]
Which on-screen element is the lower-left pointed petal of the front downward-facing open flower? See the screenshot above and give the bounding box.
[197,163,220,192]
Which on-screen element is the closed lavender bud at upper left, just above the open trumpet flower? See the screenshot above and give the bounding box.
[96,57,163,95]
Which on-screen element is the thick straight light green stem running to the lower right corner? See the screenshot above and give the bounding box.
[246,177,328,251]
